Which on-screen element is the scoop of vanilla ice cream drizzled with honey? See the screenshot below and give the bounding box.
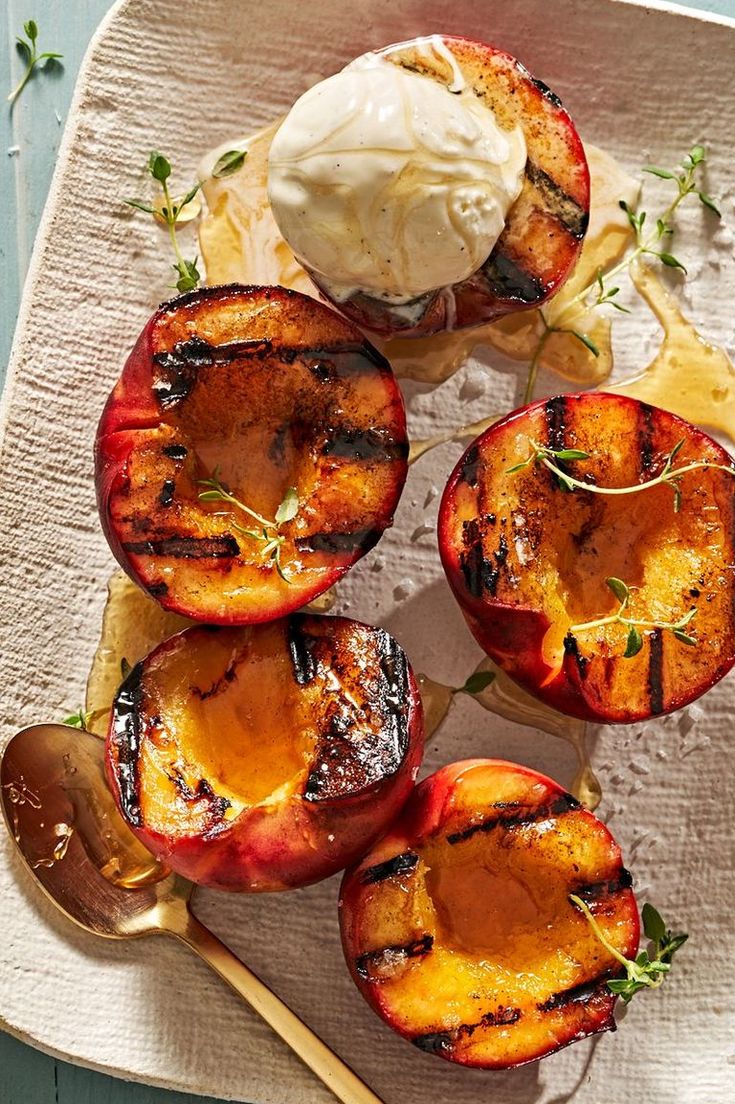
[268,54,526,302]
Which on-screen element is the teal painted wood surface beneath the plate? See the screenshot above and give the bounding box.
[0,0,735,1104]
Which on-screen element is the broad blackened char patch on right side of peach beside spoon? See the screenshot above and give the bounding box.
[302,630,409,802]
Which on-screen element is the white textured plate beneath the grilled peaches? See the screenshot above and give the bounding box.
[0,0,735,1104]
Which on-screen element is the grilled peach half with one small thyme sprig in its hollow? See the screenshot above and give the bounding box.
[96,286,408,624]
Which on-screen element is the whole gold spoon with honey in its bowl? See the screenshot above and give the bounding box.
[0,724,382,1104]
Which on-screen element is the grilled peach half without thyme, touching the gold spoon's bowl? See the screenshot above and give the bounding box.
[107,614,424,892]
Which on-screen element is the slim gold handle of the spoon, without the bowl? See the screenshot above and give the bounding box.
[169,912,383,1104]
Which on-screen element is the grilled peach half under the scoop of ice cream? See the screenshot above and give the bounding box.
[310,35,589,337]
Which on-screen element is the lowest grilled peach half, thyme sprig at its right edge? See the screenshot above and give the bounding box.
[340,760,640,1069]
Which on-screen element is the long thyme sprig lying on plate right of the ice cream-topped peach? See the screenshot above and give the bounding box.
[523,145,721,403]
